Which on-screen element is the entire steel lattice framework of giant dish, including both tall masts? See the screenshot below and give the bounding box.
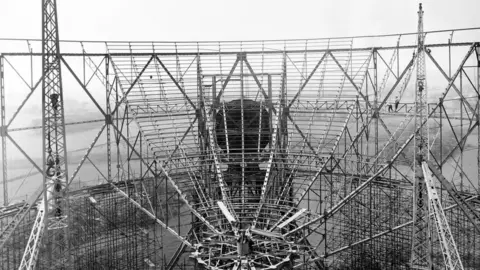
[0,1,480,269]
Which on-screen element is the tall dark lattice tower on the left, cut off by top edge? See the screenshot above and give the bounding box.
[42,0,70,269]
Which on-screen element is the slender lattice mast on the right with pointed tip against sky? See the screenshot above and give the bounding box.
[410,4,432,269]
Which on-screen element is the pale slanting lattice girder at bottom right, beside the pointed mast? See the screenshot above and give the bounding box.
[422,162,463,270]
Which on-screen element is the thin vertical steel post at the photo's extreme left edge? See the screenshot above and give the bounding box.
[0,55,8,206]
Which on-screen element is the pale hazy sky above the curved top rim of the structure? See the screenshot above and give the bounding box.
[0,0,480,40]
